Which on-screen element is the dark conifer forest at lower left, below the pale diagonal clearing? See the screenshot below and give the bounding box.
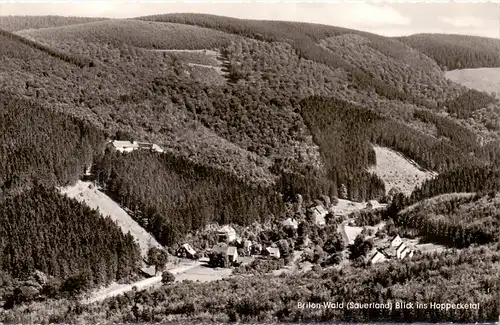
[0,185,140,300]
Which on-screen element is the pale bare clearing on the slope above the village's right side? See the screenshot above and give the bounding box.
[369,146,437,195]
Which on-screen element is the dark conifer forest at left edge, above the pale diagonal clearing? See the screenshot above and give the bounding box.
[0,91,104,199]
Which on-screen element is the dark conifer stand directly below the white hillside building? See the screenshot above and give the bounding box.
[94,150,284,246]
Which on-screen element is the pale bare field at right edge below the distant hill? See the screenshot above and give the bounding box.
[444,68,500,97]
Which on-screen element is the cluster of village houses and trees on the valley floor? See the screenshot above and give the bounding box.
[144,195,423,276]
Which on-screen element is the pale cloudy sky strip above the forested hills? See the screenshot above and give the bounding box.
[0,0,500,38]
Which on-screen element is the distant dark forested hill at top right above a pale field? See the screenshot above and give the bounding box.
[394,34,500,70]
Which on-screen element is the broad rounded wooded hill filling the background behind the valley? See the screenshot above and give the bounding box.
[2,14,500,213]
